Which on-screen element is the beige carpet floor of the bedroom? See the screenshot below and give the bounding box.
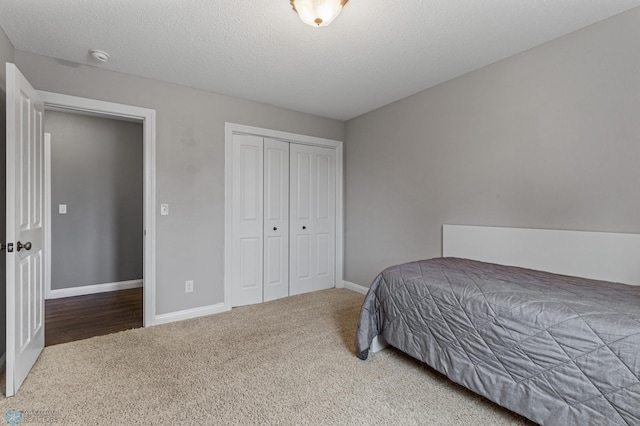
[0,289,528,425]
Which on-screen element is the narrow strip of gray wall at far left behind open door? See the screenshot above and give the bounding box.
[0,28,14,356]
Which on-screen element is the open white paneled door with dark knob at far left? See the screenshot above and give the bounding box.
[6,63,44,396]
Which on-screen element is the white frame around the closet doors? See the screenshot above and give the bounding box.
[224,122,344,309]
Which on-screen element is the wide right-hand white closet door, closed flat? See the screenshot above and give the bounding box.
[289,143,336,295]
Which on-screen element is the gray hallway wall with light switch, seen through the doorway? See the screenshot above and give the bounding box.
[45,111,143,289]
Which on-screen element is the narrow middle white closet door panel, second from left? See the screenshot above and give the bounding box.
[263,138,289,302]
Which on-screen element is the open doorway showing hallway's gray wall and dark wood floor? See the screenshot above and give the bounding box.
[44,109,143,346]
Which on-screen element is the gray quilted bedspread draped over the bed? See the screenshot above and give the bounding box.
[356,258,640,425]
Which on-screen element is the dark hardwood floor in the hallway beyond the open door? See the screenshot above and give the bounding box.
[44,288,142,346]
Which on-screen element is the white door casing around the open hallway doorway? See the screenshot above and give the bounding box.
[38,91,156,327]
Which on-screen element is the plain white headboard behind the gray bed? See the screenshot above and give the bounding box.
[442,225,640,285]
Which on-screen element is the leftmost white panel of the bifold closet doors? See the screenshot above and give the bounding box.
[231,135,264,306]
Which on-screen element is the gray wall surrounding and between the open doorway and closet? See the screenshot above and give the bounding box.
[15,51,344,314]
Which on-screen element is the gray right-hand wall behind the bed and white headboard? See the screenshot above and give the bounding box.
[345,9,640,286]
